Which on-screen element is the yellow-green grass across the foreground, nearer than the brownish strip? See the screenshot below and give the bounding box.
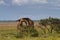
[0,30,60,40]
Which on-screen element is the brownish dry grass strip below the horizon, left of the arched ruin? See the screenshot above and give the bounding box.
[0,22,17,30]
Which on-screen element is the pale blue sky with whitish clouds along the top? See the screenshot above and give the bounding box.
[0,0,60,20]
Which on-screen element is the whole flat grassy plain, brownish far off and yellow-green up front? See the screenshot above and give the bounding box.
[0,22,60,40]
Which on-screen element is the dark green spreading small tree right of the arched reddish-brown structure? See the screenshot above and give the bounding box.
[39,17,60,33]
